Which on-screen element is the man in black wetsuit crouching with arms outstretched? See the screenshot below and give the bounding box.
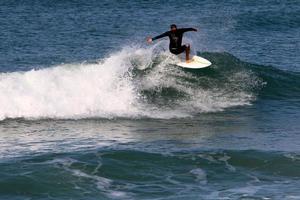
[147,24,197,62]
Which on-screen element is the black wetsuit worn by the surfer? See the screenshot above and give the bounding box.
[152,28,197,55]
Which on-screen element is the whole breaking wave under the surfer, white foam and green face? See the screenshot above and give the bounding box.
[0,46,300,120]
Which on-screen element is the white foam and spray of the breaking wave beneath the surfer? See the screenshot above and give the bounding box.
[0,46,255,120]
